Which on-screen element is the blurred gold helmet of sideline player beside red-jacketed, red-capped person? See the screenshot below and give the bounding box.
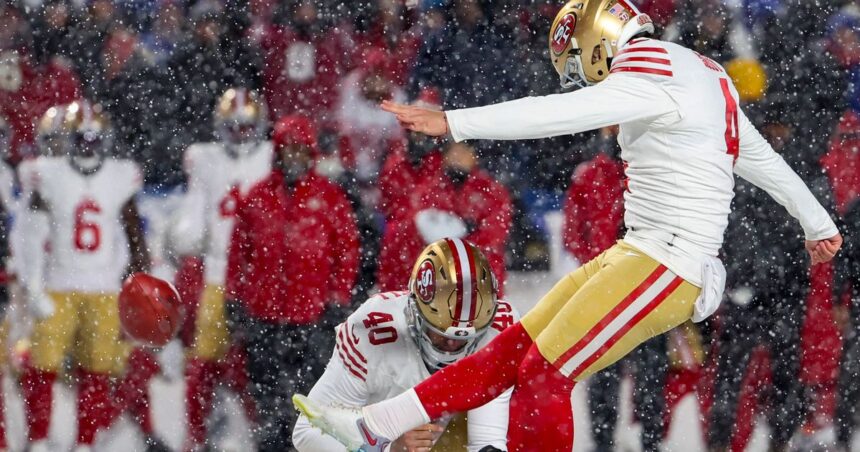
[213,88,269,147]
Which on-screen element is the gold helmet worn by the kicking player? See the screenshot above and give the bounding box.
[549,0,654,88]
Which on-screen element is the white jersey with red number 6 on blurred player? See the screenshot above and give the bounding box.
[22,157,143,292]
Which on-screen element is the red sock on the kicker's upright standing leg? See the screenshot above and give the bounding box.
[508,345,575,452]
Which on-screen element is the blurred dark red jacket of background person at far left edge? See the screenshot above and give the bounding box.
[0,57,81,157]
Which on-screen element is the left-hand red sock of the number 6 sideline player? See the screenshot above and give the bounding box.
[21,366,57,442]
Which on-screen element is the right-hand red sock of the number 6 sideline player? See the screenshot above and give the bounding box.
[78,369,110,445]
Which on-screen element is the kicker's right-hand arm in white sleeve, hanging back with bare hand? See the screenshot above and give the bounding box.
[735,112,842,265]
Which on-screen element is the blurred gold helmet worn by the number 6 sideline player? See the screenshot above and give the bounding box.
[62,100,113,173]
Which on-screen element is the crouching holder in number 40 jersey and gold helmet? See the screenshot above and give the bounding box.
[293,239,519,452]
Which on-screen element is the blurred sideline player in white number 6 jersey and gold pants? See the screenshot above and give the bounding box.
[21,101,149,451]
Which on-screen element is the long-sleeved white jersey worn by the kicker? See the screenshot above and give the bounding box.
[447,39,837,287]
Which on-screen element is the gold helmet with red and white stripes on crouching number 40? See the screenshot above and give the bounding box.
[407,238,498,370]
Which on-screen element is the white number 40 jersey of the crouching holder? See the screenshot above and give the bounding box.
[293,292,519,452]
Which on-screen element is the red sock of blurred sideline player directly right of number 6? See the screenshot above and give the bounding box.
[185,358,218,444]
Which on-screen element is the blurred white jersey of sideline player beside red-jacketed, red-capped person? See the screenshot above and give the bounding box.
[174,141,272,285]
